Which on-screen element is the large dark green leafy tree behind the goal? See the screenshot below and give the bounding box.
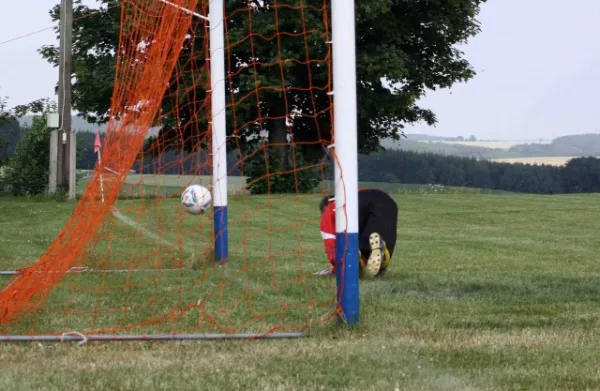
[40,0,485,193]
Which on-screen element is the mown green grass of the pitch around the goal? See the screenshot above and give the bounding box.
[0,191,600,390]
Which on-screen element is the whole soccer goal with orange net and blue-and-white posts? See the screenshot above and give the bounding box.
[0,0,359,341]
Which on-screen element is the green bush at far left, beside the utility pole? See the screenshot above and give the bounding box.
[0,115,50,196]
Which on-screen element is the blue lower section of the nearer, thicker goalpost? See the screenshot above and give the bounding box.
[335,233,360,325]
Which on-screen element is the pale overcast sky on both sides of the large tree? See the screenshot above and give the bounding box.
[0,0,600,140]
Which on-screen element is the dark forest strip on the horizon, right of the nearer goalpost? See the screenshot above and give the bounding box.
[358,151,600,194]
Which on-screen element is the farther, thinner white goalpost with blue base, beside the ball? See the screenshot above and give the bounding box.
[208,0,229,263]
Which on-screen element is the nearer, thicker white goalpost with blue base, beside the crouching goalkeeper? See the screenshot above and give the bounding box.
[331,0,360,325]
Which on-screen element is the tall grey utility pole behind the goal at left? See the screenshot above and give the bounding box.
[48,0,77,200]
